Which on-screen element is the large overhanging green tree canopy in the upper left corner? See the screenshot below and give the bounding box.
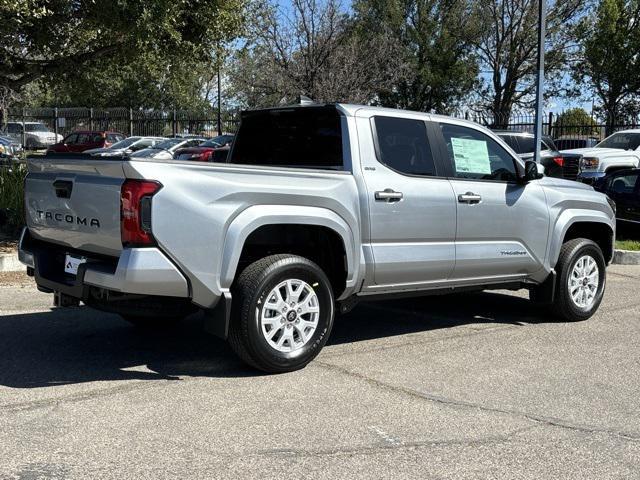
[0,0,246,104]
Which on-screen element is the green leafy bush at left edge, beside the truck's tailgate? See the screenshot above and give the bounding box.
[0,163,27,235]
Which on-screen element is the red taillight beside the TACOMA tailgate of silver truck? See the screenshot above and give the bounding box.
[120,180,162,247]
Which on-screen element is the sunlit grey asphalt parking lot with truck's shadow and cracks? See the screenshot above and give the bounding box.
[0,266,640,480]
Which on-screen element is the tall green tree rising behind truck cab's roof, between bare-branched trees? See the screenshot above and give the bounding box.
[353,0,478,113]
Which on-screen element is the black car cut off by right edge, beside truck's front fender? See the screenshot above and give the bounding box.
[593,168,640,229]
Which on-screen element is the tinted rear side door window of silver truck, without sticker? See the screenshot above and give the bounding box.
[373,116,436,176]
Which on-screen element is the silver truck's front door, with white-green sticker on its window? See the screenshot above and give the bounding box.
[437,122,549,282]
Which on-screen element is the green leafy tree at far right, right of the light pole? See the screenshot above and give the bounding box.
[574,0,640,131]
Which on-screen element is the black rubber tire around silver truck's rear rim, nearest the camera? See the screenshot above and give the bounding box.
[229,255,334,373]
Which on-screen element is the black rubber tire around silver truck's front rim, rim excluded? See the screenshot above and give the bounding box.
[551,238,607,322]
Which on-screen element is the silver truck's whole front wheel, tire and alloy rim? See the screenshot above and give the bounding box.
[552,238,606,321]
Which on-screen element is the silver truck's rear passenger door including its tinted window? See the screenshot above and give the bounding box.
[357,114,456,290]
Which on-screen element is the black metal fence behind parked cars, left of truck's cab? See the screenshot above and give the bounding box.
[0,108,239,141]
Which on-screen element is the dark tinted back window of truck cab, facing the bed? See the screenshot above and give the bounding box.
[230,106,343,170]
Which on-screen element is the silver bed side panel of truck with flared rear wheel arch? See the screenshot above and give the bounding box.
[124,160,361,308]
